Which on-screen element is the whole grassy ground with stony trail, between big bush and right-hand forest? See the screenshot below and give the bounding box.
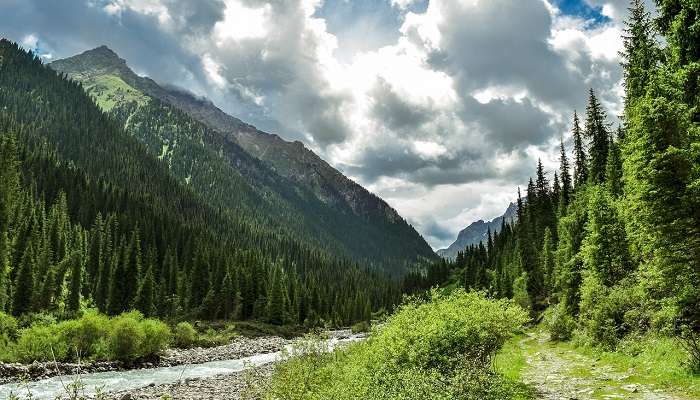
[496,330,699,400]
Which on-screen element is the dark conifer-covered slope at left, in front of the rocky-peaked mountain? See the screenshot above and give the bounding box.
[0,40,399,324]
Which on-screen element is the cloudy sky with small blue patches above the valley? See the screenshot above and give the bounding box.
[0,0,627,249]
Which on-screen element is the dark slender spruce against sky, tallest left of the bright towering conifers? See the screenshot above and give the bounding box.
[584,88,610,183]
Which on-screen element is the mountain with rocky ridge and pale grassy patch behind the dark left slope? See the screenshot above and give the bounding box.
[50,46,435,272]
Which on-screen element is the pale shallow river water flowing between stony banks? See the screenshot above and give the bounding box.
[0,335,362,400]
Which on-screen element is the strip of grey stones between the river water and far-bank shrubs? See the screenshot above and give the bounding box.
[0,336,291,384]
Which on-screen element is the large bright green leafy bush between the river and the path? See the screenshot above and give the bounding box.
[264,290,528,400]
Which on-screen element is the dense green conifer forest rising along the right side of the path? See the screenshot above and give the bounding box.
[407,0,700,369]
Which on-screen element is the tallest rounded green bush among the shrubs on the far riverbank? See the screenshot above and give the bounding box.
[108,313,145,361]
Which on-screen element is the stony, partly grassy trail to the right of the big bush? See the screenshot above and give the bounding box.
[518,332,687,400]
